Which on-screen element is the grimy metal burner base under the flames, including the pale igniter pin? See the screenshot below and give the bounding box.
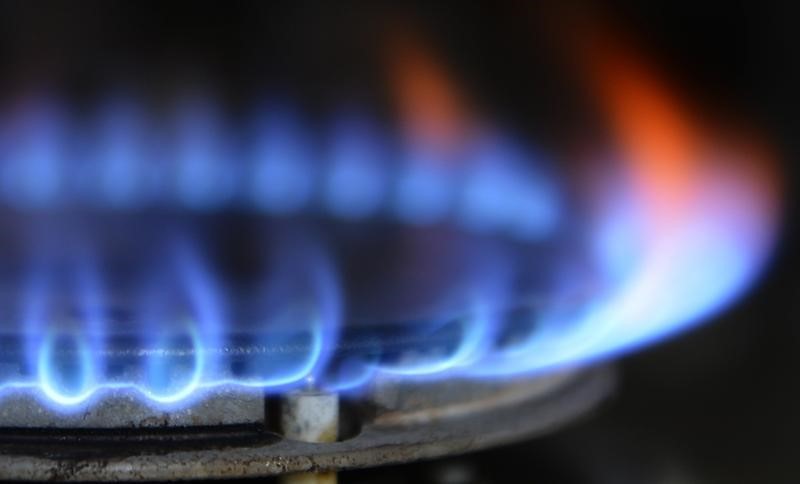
[0,368,614,482]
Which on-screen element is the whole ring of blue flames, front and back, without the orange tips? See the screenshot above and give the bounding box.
[0,91,774,411]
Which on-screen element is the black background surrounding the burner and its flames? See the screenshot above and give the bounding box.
[0,1,800,483]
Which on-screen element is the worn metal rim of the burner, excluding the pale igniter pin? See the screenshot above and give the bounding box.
[0,367,615,481]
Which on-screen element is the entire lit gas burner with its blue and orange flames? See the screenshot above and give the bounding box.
[0,1,780,482]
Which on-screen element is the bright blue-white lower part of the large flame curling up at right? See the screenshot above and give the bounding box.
[462,174,772,378]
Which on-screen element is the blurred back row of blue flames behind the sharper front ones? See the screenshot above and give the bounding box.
[0,96,562,240]
